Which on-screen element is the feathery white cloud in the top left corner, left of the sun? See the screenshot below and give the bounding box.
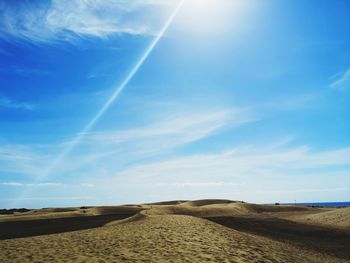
[0,0,174,43]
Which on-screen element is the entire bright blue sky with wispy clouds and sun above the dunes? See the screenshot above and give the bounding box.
[0,0,350,208]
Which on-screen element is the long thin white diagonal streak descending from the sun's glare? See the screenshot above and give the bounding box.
[41,0,185,178]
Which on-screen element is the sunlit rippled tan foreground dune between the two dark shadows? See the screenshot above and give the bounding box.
[0,215,340,262]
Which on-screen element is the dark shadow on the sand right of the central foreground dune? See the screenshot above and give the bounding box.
[206,215,350,260]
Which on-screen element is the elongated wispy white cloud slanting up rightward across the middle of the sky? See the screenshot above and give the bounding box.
[59,109,255,174]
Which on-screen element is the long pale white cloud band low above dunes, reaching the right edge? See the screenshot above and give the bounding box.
[111,146,350,187]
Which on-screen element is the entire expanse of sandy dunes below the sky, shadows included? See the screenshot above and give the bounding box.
[0,200,350,263]
